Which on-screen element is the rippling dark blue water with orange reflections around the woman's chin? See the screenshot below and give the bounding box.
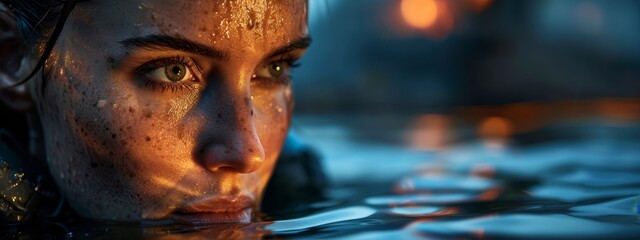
[48,117,640,239]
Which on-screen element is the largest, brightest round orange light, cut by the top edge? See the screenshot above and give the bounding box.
[400,0,438,29]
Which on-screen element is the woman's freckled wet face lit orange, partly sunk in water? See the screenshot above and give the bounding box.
[32,0,309,223]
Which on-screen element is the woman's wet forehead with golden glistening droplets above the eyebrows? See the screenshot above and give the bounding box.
[69,0,308,54]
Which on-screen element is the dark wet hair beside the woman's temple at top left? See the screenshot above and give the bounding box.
[0,0,82,87]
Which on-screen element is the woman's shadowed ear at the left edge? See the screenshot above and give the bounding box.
[0,3,33,111]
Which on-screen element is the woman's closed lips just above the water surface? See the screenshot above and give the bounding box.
[171,195,253,224]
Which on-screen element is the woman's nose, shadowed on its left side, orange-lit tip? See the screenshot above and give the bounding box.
[200,74,265,173]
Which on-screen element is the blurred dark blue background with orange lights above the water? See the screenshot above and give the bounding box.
[294,0,640,113]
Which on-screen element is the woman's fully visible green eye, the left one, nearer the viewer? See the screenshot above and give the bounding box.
[136,56,202,92]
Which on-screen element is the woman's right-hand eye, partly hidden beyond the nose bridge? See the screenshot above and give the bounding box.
[251,57,298,85]
